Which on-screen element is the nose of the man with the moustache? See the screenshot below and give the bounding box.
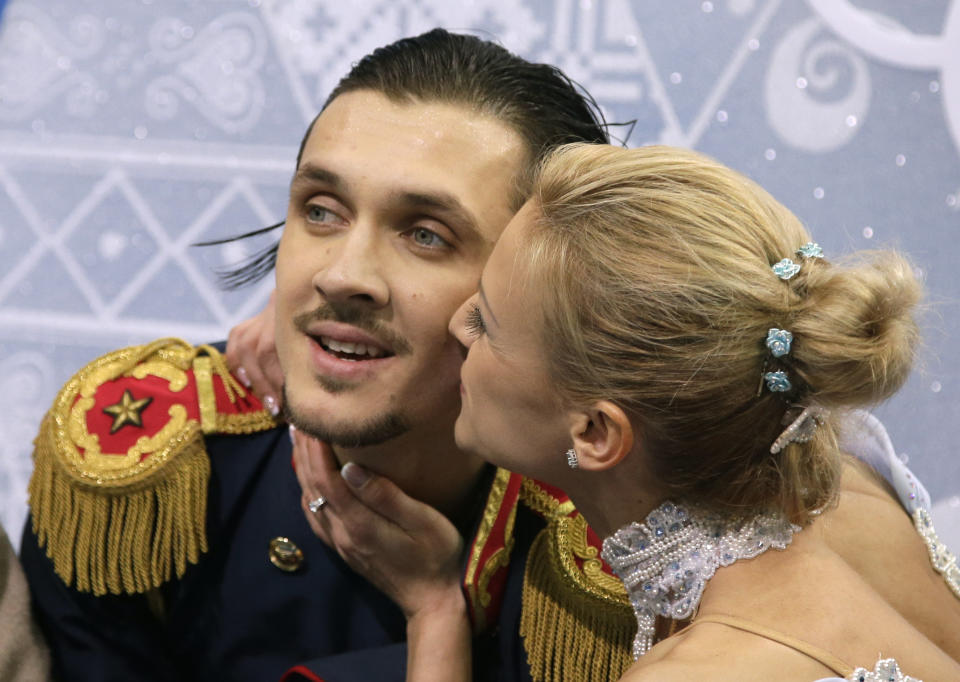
[313,225,390,307]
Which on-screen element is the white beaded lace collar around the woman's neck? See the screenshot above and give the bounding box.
[601,502,800,659]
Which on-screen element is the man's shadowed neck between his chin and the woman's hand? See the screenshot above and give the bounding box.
[334,424,485,520]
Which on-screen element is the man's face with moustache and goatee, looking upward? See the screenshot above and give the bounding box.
[276,91,525,445]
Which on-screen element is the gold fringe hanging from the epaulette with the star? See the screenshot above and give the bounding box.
[28,415,210,596]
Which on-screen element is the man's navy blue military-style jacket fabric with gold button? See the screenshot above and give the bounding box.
[21,428,543,682]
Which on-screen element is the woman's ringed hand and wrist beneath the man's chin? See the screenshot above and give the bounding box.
[290,427,472,682]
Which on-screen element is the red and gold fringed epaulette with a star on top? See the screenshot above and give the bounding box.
[29,339,275,595]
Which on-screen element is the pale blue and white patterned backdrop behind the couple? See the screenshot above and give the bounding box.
[0,0,960,548]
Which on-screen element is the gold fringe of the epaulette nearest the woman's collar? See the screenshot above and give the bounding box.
[520,528,637,682]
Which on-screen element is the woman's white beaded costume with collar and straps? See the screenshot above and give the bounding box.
[601,412,960,682]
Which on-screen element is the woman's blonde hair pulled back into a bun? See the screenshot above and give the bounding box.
[524,144,921,522]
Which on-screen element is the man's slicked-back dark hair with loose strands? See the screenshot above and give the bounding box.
[206,28,609,289]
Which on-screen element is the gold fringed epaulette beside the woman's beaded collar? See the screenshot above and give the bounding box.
[520,479,637,682]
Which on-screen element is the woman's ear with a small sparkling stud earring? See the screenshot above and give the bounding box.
[570,400,634,471]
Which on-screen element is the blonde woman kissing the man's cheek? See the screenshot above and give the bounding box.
[286,145,960,681]
